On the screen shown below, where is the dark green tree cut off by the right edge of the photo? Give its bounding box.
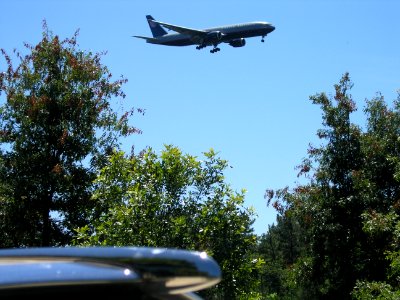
[352,94,400,300]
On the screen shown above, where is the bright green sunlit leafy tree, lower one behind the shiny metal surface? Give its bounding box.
[75,146,262,299]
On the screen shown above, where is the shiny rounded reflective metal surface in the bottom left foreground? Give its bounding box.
[0,247,221,299]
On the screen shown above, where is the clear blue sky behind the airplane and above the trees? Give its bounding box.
[0,0,400,234]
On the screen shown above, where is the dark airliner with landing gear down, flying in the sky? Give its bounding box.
[133,15,275,53]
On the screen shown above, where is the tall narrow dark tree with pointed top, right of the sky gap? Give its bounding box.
[303,74,368,299]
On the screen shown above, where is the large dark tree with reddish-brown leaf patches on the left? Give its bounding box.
[0,22,140,247]
